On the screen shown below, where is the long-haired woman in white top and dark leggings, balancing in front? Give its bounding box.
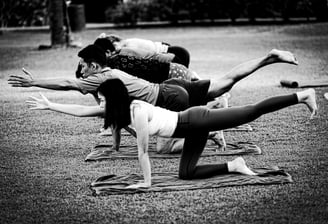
[27,79,317,188]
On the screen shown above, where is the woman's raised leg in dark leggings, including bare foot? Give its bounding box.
[174,89,317,137]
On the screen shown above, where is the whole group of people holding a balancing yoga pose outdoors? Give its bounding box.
[8,34,317,188]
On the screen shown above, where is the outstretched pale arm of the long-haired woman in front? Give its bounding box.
[26,93,104,117]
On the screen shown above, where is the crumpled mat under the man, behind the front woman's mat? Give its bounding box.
[85,142,262,162]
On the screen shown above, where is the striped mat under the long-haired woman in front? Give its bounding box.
[90,167,293,196]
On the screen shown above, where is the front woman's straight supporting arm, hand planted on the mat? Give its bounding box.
[128,106,151,188]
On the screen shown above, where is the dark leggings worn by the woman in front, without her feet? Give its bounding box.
[172,94,298,179]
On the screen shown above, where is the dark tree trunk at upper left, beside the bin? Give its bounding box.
[49,0,66,47]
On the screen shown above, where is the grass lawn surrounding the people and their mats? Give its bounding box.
[0,23,328,223]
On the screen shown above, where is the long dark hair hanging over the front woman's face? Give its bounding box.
[98,79,132,129]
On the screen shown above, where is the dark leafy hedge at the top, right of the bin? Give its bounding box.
[106,0,328,24]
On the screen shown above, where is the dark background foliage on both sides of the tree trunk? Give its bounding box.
[0,0,328,27]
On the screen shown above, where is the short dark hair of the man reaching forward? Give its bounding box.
[78,44,106,66]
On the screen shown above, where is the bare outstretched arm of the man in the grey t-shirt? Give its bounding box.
[8,68,81,91]
